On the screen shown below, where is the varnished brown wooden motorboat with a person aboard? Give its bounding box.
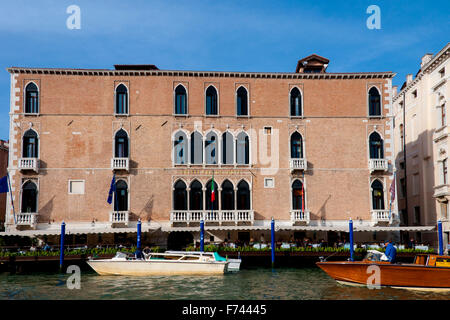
[316,250,450,291]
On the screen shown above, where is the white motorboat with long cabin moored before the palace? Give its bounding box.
[87,252,228,276]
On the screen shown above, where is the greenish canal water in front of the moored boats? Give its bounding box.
[0,267,450,300]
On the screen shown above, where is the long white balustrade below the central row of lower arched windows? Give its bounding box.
[170,210,254,225]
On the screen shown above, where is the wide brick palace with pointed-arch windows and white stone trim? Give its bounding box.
[0,54,408,248]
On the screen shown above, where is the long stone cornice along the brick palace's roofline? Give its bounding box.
[6,67,395,79]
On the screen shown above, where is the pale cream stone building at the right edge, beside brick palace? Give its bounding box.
[393,43,450,248]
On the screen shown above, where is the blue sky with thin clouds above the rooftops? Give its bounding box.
[0,0,450,140]
